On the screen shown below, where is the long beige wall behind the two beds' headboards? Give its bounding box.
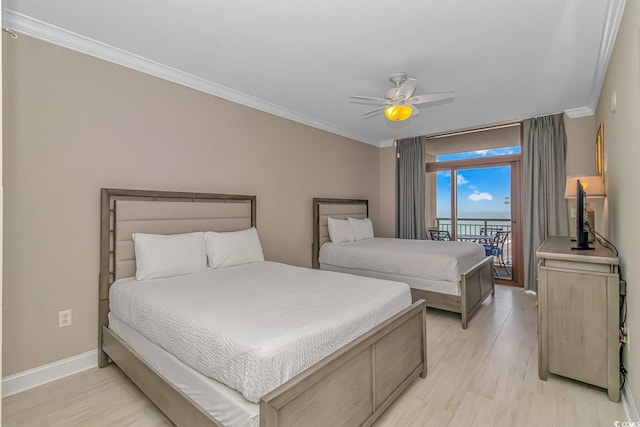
[3,35,386,376]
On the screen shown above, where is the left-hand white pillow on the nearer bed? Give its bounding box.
[132,232,207,280]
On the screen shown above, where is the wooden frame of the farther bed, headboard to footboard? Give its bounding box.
[312,198,495,329]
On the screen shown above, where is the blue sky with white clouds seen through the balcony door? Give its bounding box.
[436,147,520,218]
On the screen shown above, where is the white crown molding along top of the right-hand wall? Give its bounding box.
[578,0,626,112]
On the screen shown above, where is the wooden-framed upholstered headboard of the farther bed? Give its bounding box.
[311,198,369,268]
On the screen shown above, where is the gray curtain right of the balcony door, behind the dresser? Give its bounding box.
[522,114,569,291]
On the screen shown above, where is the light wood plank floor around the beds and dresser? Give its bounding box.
[2,286,625,427]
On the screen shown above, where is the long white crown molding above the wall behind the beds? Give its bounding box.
[2,9,370,146]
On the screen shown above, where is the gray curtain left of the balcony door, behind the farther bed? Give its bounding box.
[396,137,427,239]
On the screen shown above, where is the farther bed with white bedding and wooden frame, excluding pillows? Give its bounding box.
[312,198,495,329]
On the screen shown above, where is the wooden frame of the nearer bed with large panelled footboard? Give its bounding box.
[98,189,427,427]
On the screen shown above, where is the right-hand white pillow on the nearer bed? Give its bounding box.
[204,227,264,268]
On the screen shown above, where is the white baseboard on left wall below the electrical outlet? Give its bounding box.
[2,350,98,397]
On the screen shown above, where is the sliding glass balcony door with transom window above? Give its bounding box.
[425,124,523,286]
